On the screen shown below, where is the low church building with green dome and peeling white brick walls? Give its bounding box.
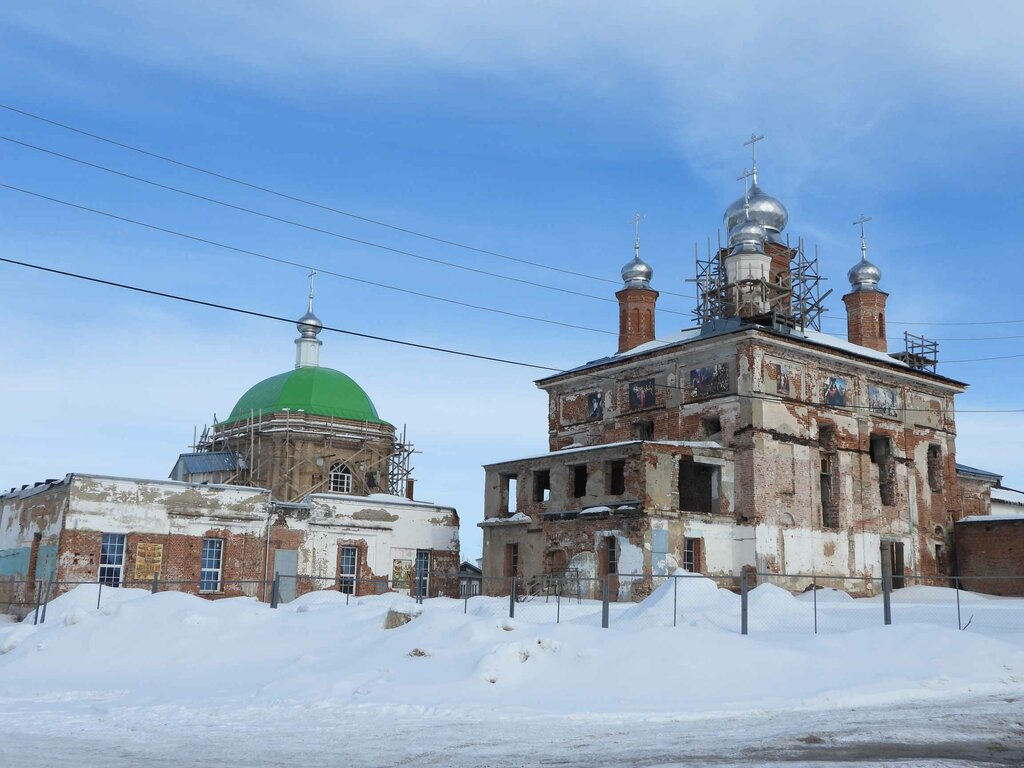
[0,291,460,611]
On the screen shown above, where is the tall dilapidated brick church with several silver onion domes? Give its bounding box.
[480,147,997,599]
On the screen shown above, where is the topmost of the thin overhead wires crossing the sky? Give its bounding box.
[0,103,694,299]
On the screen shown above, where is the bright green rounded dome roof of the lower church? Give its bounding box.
[225,367,387,424]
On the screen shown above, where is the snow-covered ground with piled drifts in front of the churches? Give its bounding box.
[0,579,1024,768]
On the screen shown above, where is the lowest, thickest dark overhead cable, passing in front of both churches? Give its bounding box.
[0,257,1024,414]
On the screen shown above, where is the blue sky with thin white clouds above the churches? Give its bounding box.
[0,1,1024,556]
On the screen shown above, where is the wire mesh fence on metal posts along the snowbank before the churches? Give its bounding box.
[0,571,1024,635]
